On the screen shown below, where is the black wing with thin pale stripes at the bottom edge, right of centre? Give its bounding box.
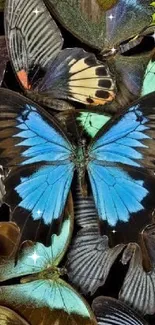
[92,296,148,325]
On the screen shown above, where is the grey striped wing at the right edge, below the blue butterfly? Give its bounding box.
[119,240,155,315]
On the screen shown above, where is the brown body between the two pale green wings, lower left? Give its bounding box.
[21,266,65,283]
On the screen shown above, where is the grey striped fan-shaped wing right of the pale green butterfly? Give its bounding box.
[67,225,125,295]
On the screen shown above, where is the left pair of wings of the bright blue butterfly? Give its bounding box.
[0,90,74,243]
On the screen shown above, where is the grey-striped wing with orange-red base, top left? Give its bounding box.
[5,0,63,89]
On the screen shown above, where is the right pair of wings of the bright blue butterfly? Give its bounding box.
[87,93,155,227]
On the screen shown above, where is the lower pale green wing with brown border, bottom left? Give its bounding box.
[0,274,97,325]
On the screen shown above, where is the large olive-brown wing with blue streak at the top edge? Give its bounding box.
[45,0,153,50]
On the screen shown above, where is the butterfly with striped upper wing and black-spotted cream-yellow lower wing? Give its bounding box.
[5,0,115,110]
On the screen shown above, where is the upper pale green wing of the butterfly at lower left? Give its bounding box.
[0,211,72,281]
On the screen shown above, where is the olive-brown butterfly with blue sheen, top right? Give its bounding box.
[44,0,154,109]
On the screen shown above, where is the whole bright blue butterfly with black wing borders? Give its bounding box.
[0,89,155,242]
